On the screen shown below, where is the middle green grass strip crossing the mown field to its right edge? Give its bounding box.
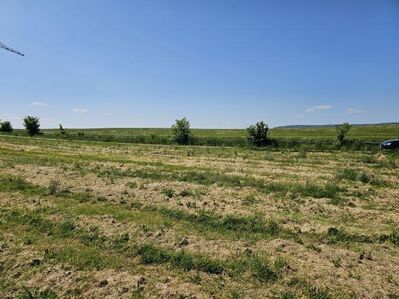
[0,176,399,251]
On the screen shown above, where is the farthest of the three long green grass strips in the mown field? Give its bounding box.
[1,139,395,207]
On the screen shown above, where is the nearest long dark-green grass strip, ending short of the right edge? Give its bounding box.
[4,210,284,282]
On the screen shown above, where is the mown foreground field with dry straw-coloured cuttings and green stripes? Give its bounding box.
[0,135,399,298]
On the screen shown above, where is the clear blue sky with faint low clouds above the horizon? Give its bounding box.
[0,0,399,128]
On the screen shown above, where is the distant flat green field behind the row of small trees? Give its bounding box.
[6,124,399,147]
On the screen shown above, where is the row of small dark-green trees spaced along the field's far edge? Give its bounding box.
[0,116,351,147]
